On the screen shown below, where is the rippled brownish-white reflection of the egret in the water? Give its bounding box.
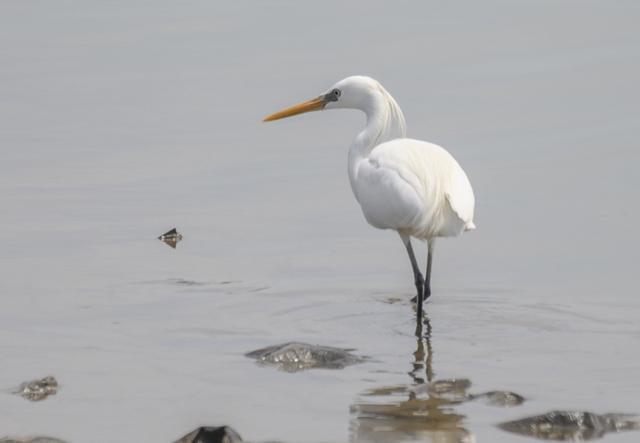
[350,316,475,443]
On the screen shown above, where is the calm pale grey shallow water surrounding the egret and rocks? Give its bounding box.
[0,0,640,443]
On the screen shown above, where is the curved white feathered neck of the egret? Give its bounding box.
[349,86,407,187]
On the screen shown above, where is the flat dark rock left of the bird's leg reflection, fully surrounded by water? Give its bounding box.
[246,342,365,372]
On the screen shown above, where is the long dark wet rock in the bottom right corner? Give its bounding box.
[498,411,640,441]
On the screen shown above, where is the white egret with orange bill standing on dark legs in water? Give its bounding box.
[264,76,475,328]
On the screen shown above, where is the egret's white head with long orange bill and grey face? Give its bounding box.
[264,75,383,122]
